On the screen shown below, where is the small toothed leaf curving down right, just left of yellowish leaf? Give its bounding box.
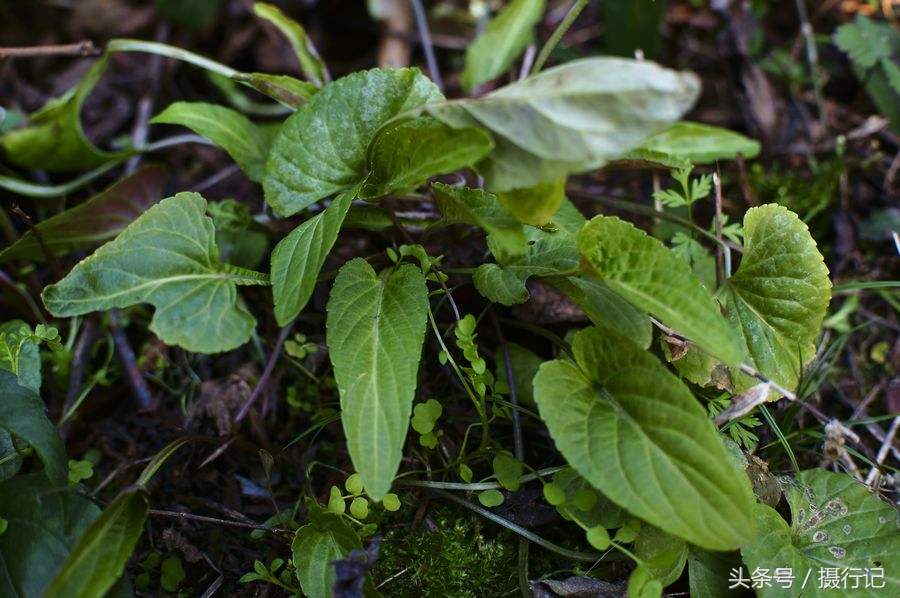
[431,183,526,259]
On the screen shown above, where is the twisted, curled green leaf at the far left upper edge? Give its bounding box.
[0,54,133,172]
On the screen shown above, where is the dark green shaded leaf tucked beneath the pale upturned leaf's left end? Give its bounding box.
[359,117,494,199]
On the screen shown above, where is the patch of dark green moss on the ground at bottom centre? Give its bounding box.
[374,507,518,598]
